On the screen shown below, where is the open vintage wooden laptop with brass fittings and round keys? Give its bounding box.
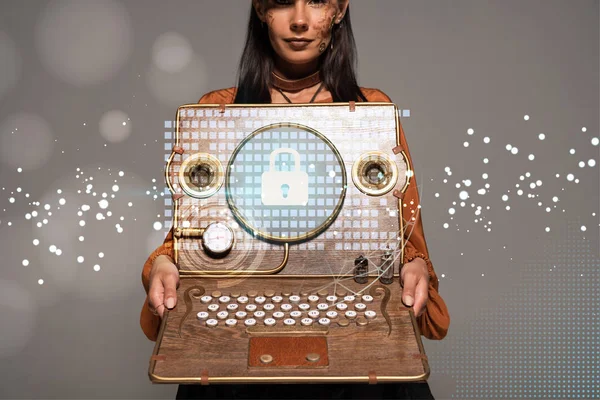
[149,103,429,384]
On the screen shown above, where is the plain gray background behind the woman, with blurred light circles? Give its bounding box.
[0,0,600,398]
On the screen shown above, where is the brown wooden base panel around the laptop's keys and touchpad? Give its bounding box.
[149,277,429,383]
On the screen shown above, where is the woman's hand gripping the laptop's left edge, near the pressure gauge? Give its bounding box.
[148,255,179,318]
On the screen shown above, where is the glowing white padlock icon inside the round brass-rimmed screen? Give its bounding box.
[260,148,308,206]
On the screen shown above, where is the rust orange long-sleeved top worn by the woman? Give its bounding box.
[140,88,450,341]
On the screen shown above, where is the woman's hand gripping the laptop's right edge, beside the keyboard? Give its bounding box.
[400,258,429,317]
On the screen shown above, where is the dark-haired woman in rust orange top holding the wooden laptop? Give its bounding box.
[141,0,450,398]
